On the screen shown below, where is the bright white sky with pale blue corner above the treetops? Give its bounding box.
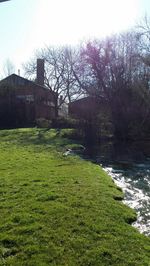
[0,0,150,76]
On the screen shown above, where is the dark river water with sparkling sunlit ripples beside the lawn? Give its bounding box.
[84,142,150,236]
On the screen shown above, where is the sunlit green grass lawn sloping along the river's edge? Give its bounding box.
[0,129,150,266]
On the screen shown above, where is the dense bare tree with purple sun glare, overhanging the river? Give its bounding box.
[76,32,150,138]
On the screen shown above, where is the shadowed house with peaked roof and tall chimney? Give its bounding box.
[0,59,55,127]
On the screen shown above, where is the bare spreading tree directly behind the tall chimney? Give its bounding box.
[24,46,84,116]
